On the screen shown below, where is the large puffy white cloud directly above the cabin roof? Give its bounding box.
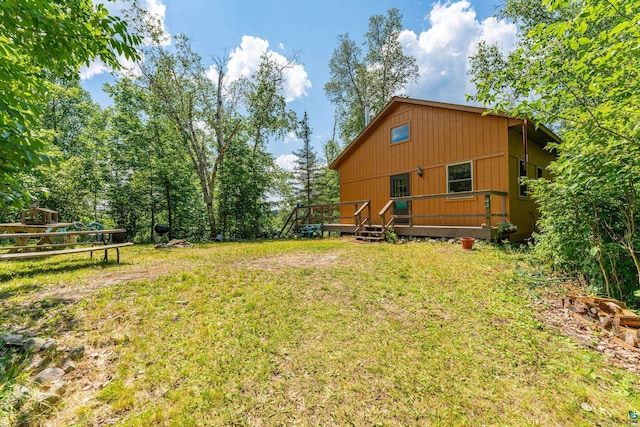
[400,0,517,103]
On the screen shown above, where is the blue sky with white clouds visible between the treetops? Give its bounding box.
[81,0,516,171]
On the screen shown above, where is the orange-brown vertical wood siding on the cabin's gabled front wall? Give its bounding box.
[338,103,510,226]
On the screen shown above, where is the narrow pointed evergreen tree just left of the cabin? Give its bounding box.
[293,111,320,205]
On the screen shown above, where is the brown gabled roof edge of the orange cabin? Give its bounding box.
[329,96,560,169]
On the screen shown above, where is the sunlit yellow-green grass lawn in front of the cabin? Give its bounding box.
[0,239,640,426]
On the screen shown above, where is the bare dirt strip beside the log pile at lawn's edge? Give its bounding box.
[540,298,640,373]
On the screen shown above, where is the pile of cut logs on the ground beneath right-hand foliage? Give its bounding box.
[561,297,640,352]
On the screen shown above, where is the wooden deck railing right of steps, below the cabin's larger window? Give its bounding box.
[378,190,507,234]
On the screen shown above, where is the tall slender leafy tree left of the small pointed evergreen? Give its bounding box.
[218,53,296,238]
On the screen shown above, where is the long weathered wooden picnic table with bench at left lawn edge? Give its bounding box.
[0,229,133,262]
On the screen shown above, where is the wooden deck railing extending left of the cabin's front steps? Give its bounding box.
[280,200,371,236]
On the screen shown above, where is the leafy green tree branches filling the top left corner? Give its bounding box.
[0,0,140,206]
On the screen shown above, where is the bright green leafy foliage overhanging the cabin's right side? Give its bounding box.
[473,0,640,298]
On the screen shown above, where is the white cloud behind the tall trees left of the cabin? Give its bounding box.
[207,36,312,102]
